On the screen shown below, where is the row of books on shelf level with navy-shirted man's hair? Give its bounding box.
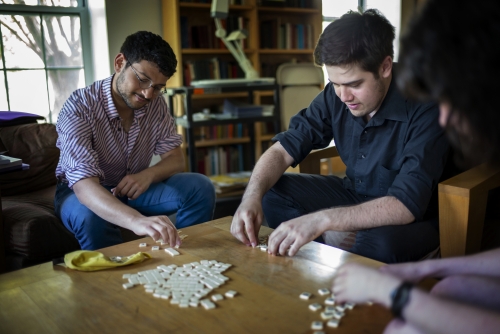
[260,18,315,50]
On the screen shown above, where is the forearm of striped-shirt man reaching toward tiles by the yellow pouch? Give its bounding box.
[73,177,142,229]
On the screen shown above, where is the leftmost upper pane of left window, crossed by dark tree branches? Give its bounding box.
[0,15,43,68]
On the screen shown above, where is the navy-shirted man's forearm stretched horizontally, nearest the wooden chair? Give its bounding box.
[316,196,415,231]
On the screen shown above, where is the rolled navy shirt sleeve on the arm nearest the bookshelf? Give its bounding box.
[272,85,333,167]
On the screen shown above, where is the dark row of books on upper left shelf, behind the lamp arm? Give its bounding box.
[180,15,248,49]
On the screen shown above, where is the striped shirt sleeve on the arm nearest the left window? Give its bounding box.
[56,91,104,188]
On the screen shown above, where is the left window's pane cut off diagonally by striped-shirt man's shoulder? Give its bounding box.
[47,70,85,123]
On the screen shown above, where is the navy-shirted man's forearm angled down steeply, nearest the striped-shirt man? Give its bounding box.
[243,142,293,199]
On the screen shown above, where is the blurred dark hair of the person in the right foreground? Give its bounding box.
[397,0,500,162]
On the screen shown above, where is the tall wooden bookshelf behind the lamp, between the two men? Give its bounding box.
[162,0,322,176]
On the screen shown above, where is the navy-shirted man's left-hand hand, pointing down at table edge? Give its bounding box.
[231,199,264,247]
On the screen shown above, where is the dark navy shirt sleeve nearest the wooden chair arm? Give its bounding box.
[387,104,449,221]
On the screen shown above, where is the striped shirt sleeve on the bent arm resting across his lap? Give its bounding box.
[154,98,182,155]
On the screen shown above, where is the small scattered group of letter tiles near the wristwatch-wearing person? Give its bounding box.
[299,288,355,334]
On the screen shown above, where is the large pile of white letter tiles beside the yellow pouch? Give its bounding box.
[123,260,237,310]
